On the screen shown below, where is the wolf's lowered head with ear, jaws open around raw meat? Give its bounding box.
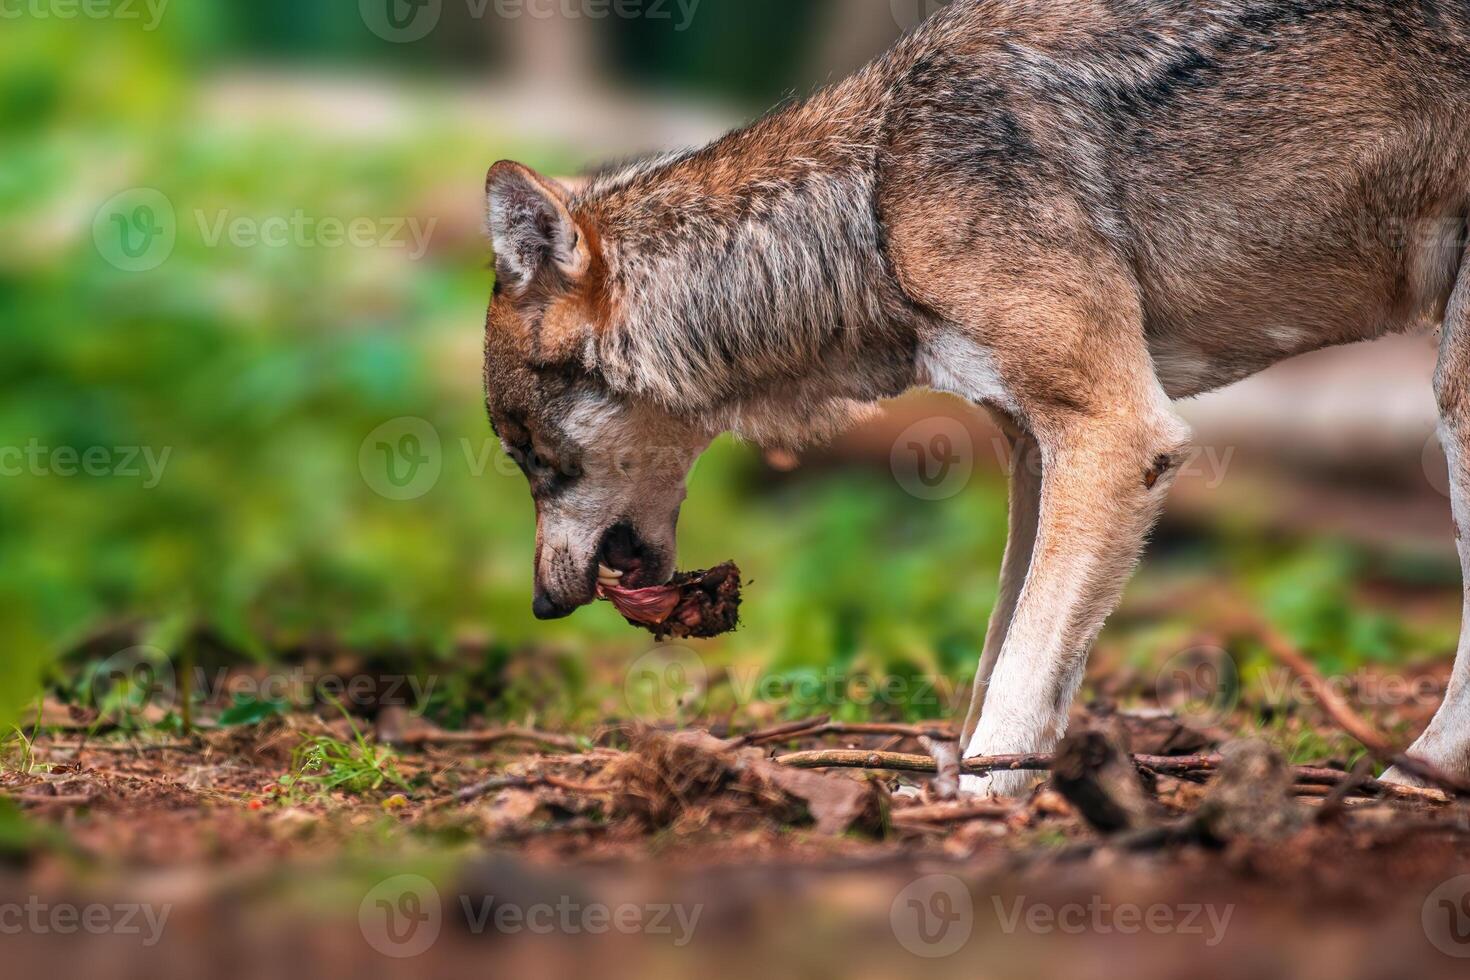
[485,163,713,619]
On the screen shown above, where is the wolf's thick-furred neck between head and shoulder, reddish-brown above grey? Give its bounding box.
[582,88,901,437]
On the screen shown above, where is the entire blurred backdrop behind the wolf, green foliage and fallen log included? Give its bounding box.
[0,0,1460,975]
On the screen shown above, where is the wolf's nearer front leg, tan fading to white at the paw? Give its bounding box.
[963,405,1189,796]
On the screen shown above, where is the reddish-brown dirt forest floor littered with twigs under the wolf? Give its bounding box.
[0,677,1470,979]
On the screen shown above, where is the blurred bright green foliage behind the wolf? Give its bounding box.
[0,3,1452,746]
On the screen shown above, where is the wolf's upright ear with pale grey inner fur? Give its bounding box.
[485,160,591,289]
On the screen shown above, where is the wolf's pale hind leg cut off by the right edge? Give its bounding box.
[1385,260,1470,783]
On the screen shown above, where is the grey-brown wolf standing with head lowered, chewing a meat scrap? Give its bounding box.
[485,0,1470,795]
